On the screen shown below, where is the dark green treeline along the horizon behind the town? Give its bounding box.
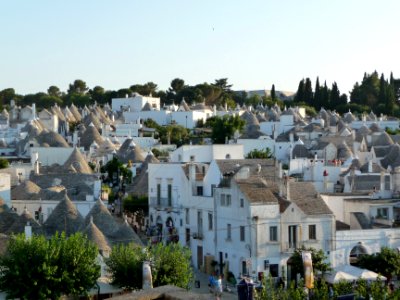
[0,71,400,117]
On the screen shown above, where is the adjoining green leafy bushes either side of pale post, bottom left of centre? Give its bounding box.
[106,243,193,290]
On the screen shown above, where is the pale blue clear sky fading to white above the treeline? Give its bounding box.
[0,0,400,94]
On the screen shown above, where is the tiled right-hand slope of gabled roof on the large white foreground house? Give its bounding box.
[288,181,333,215]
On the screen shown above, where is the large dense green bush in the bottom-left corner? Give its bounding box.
[0,233,100,299]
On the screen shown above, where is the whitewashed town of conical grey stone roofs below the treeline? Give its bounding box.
[0,93,400,299]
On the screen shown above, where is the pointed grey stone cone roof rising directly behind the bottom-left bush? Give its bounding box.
[44,195,84,236]
